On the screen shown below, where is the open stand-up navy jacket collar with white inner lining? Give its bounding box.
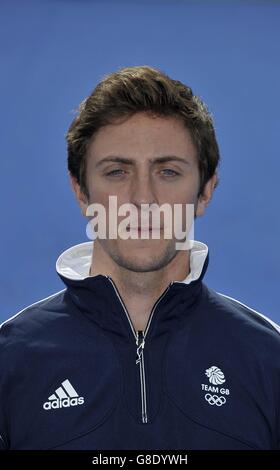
[56,241,209,340]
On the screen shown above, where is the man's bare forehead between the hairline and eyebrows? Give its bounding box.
[88,113,196,163]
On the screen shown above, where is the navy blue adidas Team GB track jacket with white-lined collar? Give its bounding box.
[0,242,280,450]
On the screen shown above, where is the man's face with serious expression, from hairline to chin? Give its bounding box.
[71,113,213,272]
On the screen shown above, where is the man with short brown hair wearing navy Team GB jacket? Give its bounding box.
[0,66,280,450]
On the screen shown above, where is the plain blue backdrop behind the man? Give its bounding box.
[0,0,280,321]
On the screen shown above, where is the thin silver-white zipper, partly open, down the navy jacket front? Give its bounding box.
[106,276,174,424]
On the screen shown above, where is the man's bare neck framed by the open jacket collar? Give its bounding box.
[90,241,190,331]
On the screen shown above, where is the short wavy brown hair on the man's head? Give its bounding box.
[66,65,220,197]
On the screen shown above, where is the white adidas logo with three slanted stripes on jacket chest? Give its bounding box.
[43,379,85,410]
